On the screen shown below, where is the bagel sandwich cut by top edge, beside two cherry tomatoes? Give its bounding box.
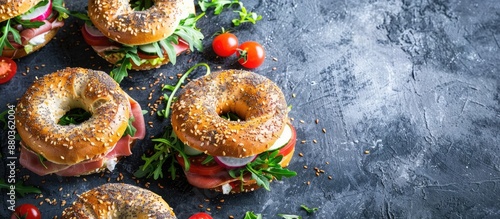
[81,0,203,82]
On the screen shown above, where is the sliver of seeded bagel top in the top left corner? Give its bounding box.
[0,0,42,22]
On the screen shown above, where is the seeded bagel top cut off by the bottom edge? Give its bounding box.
[62,183,177,219]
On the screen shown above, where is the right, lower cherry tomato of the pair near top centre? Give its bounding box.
[236,41,266,68]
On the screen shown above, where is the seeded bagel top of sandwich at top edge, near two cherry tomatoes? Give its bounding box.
[88,0,195,45]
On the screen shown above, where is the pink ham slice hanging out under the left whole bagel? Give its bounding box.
[20,97,146,176]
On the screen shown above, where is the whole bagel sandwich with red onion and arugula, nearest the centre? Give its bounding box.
[171,70,296,194]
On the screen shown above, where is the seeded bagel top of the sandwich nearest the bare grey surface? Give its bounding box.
[171,70,288,157]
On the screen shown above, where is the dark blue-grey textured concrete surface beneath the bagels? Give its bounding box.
[0,0,500,218]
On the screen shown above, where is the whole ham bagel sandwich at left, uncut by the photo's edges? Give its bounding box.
[15,68,145,176]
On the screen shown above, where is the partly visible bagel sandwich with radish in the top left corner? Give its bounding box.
[0,0,68,59]
